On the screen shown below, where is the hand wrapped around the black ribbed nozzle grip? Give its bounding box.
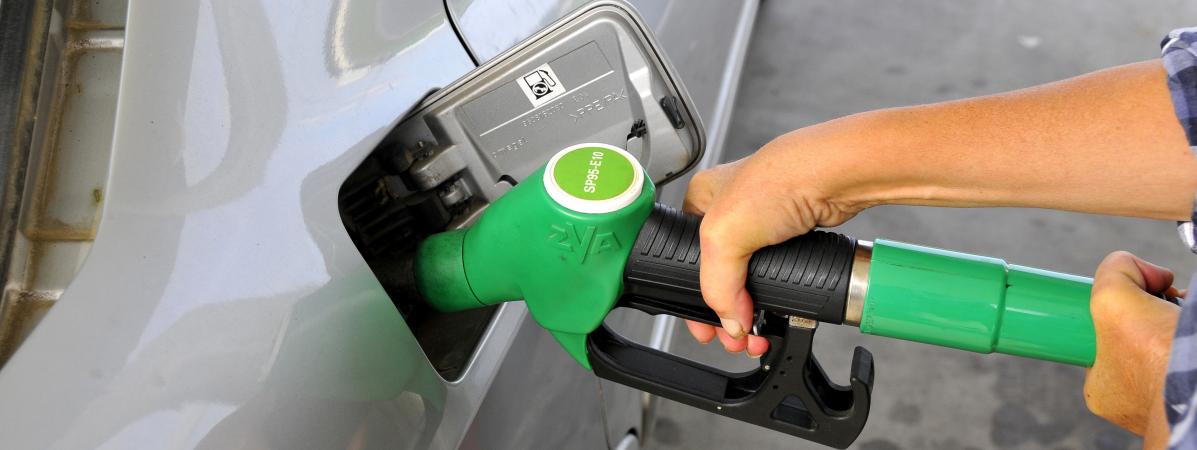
[685,130,863,358]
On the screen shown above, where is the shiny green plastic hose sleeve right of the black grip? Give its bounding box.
[861,239,1096,367]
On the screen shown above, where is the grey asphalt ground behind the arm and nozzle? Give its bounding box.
[646,0,1197,450]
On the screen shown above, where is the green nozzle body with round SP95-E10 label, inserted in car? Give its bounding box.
[414,144,655,369]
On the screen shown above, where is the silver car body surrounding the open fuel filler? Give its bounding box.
[0,0,755,449]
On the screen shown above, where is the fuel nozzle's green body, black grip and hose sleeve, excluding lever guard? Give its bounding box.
[417,145,1095,367]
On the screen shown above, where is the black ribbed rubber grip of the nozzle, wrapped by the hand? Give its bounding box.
[624,205,856,324]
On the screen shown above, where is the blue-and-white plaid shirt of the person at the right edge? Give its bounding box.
[1162,28,1197,450]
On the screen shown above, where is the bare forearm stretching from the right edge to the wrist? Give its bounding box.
[782,61,1197,219]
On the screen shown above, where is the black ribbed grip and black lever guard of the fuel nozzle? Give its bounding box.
[596,205,874,448]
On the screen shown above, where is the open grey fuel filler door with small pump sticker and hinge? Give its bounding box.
[388,2,704,201]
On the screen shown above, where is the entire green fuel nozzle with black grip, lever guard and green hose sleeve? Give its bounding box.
[414,144,1095,448]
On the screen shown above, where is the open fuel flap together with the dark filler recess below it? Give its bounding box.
[340,2,704,379]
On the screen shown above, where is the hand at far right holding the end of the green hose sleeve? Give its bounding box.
[1084,251,1181,448]
